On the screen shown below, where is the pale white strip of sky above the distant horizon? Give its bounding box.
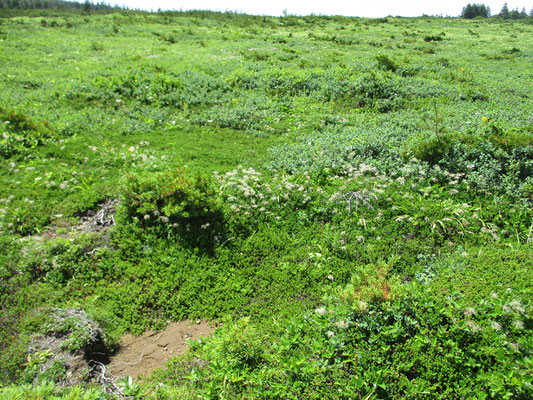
[102,0,533,18]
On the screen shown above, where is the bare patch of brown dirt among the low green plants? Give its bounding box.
[107,321,215,378]
